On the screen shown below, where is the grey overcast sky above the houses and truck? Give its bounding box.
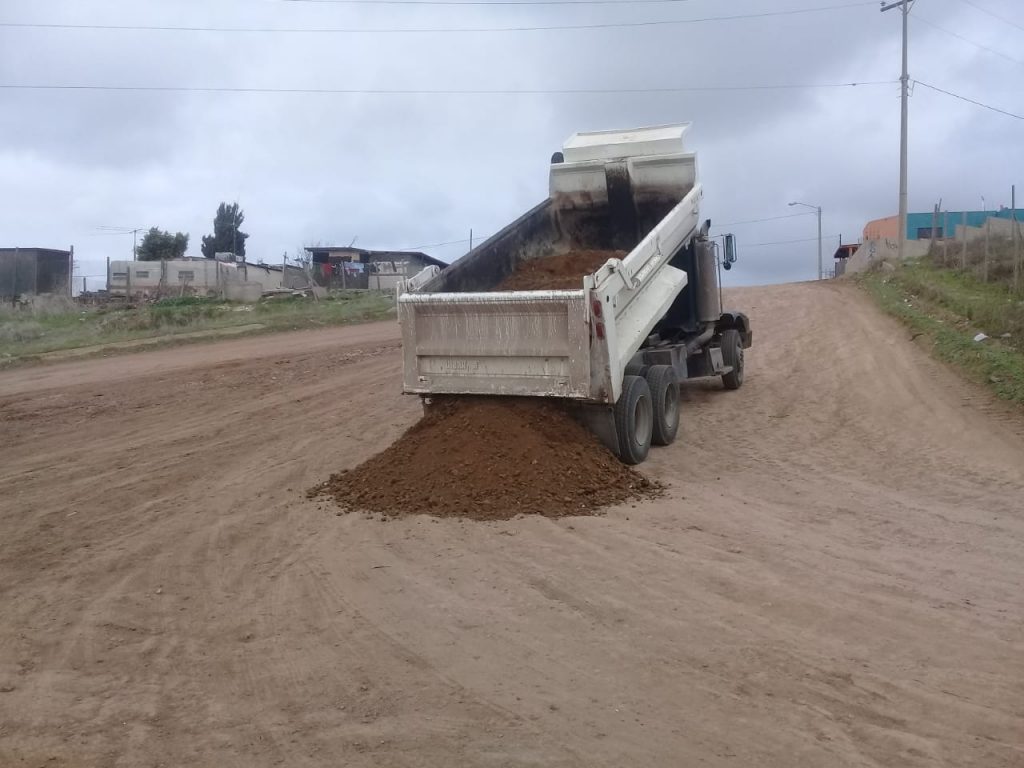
[0,0,1024,288]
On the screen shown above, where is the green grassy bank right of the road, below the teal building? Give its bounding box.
[857,262,1024,406]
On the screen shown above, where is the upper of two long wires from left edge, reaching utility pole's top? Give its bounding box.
[0,0,874,35]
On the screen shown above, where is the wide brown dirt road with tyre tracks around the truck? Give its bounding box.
[0,284,1024,768]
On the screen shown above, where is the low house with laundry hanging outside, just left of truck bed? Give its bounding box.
[306,246,447,291]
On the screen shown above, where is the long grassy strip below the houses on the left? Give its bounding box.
[0,291,394,367]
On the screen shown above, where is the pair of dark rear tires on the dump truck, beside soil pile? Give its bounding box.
[614,366,679,465]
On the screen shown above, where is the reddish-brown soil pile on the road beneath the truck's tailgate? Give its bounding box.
[310,397,659,520]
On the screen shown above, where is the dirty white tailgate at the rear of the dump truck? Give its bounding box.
[398,291,591,399]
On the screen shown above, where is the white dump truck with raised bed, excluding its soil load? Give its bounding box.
[398,124,752,464]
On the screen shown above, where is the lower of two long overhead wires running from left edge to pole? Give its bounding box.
[0,80,895,96]
